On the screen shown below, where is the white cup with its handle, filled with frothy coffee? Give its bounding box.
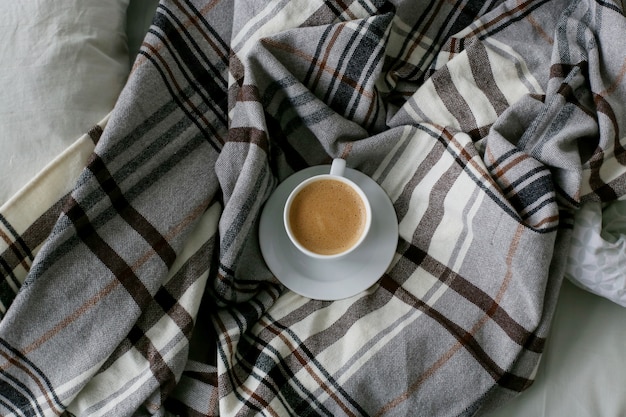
[283,158,372,259]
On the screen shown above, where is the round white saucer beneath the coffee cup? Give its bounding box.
[259,165,398,300]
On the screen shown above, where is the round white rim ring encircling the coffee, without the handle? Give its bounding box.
[283,174,372,259]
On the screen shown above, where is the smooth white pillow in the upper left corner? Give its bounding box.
[0,0,130,206]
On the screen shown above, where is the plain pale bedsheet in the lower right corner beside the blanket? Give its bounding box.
[489,281,626,417]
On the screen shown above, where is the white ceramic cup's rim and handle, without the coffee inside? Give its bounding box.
[283,158,372,259]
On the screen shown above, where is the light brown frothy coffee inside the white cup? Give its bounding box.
[289,179,366,255]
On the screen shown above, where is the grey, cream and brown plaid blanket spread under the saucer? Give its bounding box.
[0,0,626,416]
